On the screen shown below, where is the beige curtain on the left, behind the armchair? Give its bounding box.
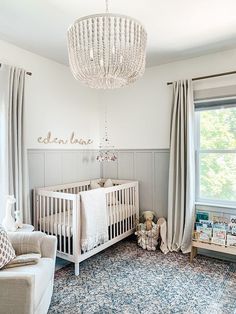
[0,64,30,222]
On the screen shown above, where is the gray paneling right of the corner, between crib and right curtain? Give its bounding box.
[102,149,169,217]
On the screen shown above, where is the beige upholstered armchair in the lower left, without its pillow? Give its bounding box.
[0,232,56,314]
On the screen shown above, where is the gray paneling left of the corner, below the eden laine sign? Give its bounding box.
[28,149,101,190]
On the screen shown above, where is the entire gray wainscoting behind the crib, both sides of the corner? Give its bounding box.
[28,149,169,217]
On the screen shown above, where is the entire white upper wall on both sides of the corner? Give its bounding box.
[0,41,236,149]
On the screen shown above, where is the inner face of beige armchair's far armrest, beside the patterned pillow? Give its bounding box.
[8,231,46,255]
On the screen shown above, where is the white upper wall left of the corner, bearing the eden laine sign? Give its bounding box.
[0,41,99,149]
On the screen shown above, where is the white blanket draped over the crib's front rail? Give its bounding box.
[80,188,108,252]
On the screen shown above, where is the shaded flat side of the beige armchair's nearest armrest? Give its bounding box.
[0,271,34,314]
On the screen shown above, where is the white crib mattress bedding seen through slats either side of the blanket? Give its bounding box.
[38,204,135,237]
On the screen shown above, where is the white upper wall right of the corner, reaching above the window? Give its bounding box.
[99,49,236,149]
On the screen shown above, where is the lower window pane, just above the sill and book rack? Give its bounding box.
[199,153,236,201]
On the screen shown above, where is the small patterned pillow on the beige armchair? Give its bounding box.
[0,226,16,269]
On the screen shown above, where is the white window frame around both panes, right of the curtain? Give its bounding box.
[194,100,236,209]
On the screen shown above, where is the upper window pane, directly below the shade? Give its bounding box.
[200,107,236,149]
